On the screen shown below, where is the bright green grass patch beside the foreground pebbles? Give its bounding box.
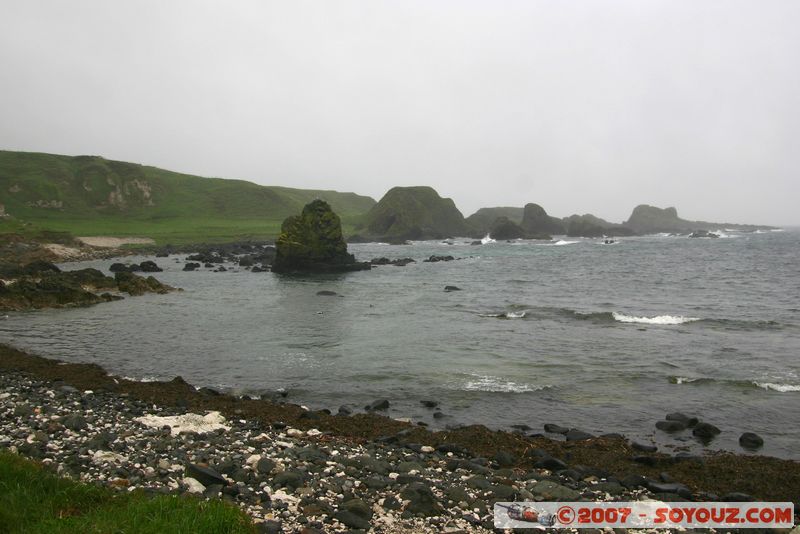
[0,451,255,534]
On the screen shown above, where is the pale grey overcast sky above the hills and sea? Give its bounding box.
[0,0,800,224]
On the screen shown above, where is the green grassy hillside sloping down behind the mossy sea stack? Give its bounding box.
[0,151,375,242]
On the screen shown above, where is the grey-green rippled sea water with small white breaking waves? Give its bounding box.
[0,230,800,459]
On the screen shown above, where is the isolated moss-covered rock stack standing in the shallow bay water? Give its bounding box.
[272,200,371,273]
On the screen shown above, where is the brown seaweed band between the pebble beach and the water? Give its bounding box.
[0,345,800,510]
